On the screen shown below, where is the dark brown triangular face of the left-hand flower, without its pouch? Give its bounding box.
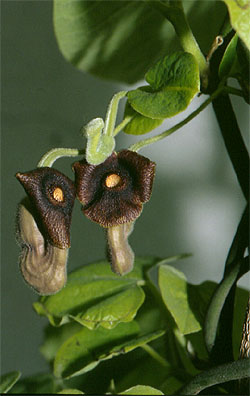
[16,167,75,249]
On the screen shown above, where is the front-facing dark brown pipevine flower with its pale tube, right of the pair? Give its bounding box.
[73,150,155,275]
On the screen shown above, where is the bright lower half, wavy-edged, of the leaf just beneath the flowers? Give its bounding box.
[72,286,145,329]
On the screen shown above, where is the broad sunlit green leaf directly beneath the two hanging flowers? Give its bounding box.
[33,257,157,328]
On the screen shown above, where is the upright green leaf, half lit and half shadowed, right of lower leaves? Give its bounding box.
[159,265,216,335]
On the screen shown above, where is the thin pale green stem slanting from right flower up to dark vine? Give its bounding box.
[129,88,224,152]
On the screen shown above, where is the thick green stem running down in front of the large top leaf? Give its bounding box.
[149,0,208,80]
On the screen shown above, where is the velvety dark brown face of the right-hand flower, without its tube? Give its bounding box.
[73,150,155,227]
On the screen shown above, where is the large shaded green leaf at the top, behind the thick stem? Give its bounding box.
[54,0,226,83]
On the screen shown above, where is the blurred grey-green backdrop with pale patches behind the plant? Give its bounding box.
[1,0,249,375]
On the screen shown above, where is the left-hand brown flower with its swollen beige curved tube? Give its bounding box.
[16,167,75,295]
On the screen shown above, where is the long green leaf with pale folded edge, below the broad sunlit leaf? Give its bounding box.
[54,321,164,378]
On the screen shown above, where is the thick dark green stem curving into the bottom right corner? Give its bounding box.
[178,359,250,395]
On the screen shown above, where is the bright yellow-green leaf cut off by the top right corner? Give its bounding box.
[223,0,250,49]
